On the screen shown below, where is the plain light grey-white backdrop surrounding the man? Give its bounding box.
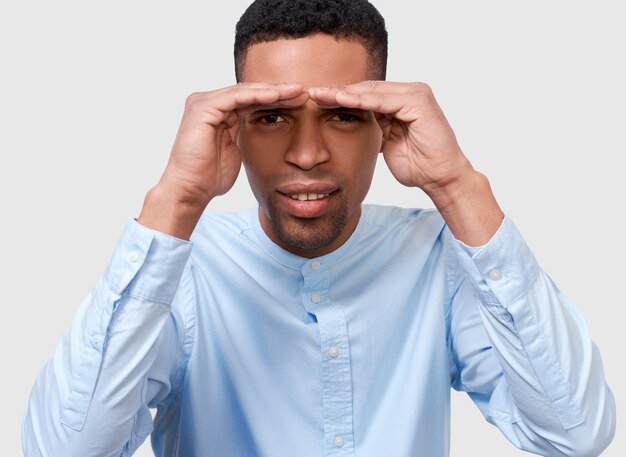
[0,0,626,457]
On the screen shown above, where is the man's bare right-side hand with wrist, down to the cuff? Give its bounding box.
[308,81,504,245]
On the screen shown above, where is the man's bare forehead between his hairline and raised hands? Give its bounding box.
[243,34,372,88]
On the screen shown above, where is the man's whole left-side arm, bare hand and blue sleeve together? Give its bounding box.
[22,83,308,457]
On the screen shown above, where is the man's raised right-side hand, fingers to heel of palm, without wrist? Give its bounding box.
[309,81,474,193]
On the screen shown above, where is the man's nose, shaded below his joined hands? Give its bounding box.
[284,119,330,170]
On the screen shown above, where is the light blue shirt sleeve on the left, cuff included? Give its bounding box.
[22,219,195,457]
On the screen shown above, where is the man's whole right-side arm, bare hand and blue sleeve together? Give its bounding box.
[309,81,615,456]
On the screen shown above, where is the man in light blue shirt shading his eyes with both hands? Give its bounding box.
[23,0,615,457]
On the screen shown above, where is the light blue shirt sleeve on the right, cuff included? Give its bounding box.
[444,215,615,456]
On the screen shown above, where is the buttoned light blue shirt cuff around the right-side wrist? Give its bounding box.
[453,215,539,308]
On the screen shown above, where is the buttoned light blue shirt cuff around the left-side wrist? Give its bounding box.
[104,218,193,304]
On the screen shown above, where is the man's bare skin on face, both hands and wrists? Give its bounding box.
[138,34,504,253]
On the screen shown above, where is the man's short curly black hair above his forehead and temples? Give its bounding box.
[235,0,387,82]
